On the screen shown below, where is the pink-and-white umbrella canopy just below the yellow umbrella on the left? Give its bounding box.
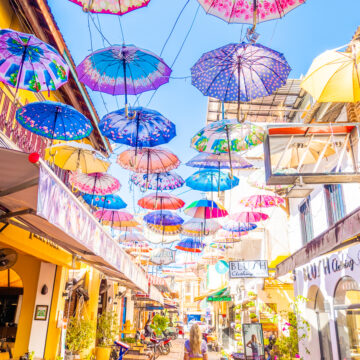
[69,171,121,195]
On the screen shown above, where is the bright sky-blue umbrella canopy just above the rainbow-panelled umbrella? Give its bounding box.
[186,169,239,191]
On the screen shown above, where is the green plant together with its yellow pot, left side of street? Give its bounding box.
[95,311,118,360]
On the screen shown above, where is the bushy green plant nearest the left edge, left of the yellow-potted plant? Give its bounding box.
[65,317,94,354]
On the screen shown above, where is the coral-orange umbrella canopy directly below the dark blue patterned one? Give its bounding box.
[117,147,180,174]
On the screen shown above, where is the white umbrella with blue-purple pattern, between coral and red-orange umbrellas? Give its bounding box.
[130,171,185,191]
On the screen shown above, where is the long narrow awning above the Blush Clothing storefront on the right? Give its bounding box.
[276,204,360,277]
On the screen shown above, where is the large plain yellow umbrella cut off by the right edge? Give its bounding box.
[301,45,360,102]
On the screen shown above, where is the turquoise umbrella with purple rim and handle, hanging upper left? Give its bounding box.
[76,45,171,114]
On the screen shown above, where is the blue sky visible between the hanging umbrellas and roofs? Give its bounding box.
[48,0,360,211]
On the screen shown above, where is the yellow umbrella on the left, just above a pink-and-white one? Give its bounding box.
[45,141,110,174]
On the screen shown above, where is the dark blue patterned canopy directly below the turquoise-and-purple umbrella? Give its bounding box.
[99,107,176,149]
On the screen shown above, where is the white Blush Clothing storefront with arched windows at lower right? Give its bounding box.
[295,245,360,360]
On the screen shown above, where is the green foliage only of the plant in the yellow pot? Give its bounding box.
[96,311,118,347]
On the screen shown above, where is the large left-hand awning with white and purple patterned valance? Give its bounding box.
[0,148,148,292]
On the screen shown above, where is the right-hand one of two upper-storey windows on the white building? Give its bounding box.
[324,184,345,226]
